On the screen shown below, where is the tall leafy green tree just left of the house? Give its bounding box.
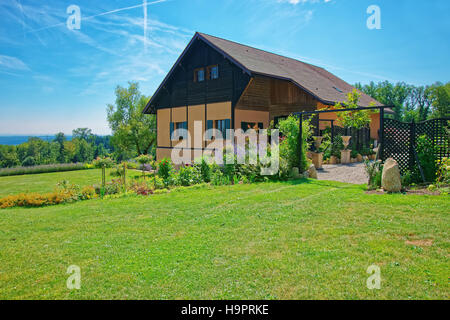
[107,82,156,155]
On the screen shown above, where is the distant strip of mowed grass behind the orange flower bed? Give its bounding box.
[0,169,141,197]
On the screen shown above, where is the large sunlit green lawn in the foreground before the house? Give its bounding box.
[0,180,450,299]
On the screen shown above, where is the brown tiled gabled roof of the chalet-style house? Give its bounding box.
[144,32,383,112]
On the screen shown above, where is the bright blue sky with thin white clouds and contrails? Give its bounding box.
[0,0,450,134]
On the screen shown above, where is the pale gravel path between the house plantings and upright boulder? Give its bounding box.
[317,163,368,184]
